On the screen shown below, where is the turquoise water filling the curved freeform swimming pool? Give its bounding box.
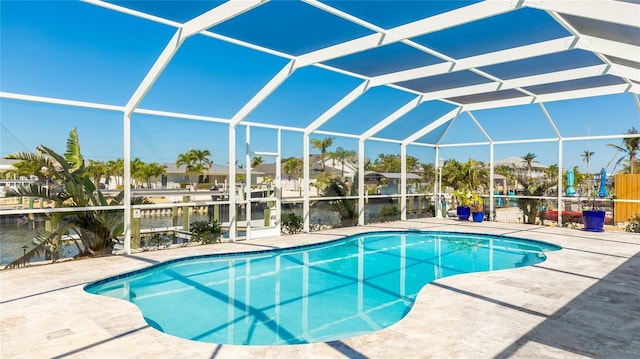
[85,231,560,345]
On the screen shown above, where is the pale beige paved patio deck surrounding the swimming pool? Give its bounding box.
[0,219,640,358]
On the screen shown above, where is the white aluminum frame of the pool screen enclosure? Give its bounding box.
[0,0,640,254]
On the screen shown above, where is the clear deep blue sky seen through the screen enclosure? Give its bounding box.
[0,0,640,172]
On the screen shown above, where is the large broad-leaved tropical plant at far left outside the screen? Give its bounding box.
[6,128,134,268]
